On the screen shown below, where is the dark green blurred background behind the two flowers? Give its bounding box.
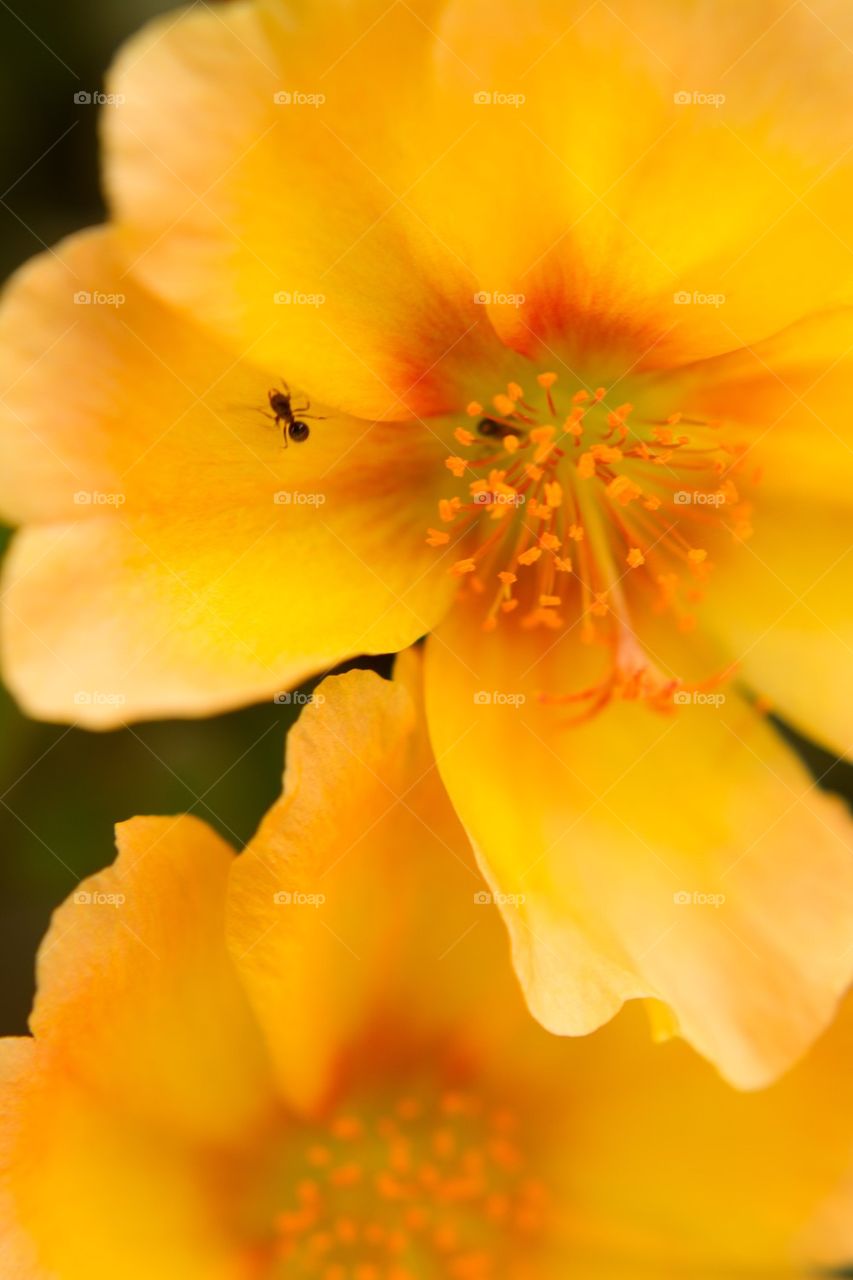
[0,0,853,1034]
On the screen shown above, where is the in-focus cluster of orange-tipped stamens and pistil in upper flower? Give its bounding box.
[427,372,752,716]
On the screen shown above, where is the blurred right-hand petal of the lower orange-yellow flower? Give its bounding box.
[540,998,853,1276]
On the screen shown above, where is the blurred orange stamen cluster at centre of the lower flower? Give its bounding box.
[262,1091,547,1280]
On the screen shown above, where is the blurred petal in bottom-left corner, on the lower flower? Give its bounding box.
[0,1039,246,1280]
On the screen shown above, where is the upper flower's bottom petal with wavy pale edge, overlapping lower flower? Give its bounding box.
[427,613,853,1088]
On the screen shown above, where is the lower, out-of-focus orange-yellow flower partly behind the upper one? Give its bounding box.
[0,671,853,1280]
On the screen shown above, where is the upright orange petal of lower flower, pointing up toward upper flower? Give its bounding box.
[229,657,489,1108]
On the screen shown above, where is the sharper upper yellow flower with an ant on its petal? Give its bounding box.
[0,0,853,1087]
